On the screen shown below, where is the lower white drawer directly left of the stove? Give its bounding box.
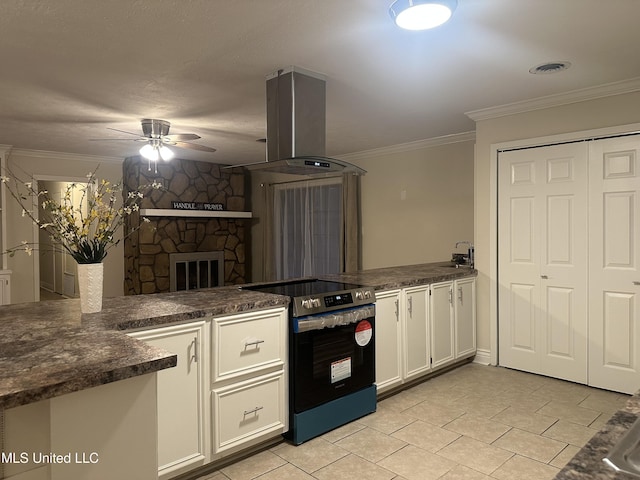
[211,371,287,453]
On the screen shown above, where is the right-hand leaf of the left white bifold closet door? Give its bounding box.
[539,156,587,383]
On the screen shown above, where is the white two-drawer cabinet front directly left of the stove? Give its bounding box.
[211,308,289,459]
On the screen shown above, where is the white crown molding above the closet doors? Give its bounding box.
[465,77,640,122]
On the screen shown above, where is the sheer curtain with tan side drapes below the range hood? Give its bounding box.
[262,174,362,281]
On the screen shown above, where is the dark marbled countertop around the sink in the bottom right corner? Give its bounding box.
[555,392,640,480]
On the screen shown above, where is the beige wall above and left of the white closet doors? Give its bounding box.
[475,92,640,351]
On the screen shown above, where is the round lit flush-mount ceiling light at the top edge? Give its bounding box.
[389,0,458,30]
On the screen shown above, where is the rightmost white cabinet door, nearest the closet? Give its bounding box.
[454,277,476,358]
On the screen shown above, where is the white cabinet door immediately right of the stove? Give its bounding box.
[375,290,402,393]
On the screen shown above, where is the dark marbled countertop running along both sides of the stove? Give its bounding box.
[0,262,476,409]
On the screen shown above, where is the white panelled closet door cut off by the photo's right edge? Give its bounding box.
[589,135,640,393]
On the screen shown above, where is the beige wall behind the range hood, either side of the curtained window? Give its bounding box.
[251,136,474,281]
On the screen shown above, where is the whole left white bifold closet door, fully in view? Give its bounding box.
[498,142,588,383]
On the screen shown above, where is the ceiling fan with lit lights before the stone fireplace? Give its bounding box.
[92,118,216,173]
